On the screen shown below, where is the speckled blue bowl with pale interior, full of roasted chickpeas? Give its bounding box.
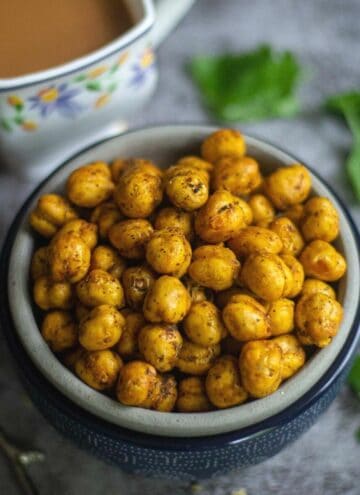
[1,125,360,480]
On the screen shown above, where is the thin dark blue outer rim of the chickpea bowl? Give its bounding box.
[0,123,360,451]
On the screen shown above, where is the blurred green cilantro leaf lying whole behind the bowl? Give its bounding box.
[190,45,301,121]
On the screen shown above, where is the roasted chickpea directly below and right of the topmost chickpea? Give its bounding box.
[212,156,263,196]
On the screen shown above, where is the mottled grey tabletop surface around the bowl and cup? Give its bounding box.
[0,0,360,495]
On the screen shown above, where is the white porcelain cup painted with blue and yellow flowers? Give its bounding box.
[0,0,194,179]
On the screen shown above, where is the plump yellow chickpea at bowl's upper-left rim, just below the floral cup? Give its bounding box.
[66,162,114,208]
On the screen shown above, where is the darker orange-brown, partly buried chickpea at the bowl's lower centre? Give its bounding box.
[176,340,221,375]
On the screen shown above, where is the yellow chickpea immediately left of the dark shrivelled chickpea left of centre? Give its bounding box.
[76,269,125,308]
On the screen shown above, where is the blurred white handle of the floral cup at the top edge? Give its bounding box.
[152,0,195,48]
